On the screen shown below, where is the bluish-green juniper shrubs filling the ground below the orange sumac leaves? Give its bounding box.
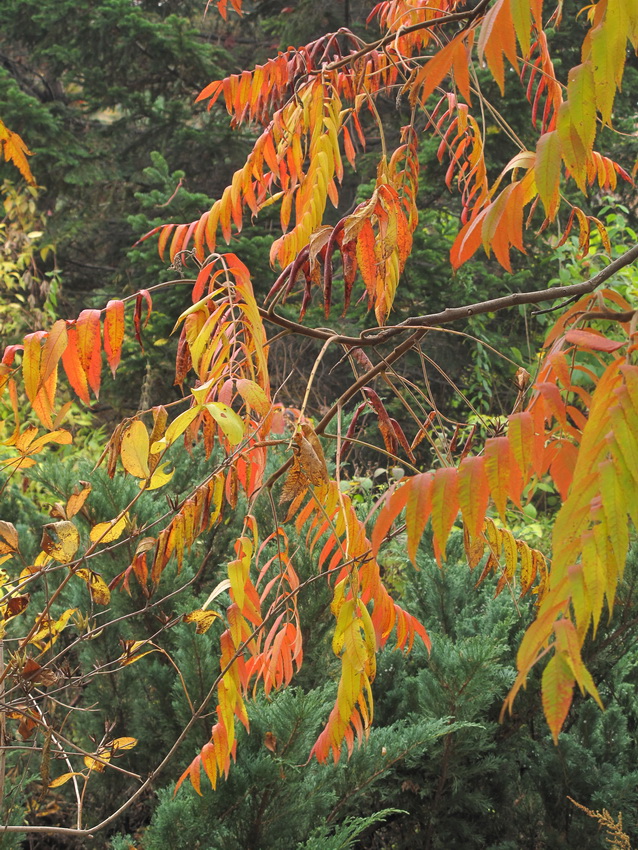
[6,444,638,850]
